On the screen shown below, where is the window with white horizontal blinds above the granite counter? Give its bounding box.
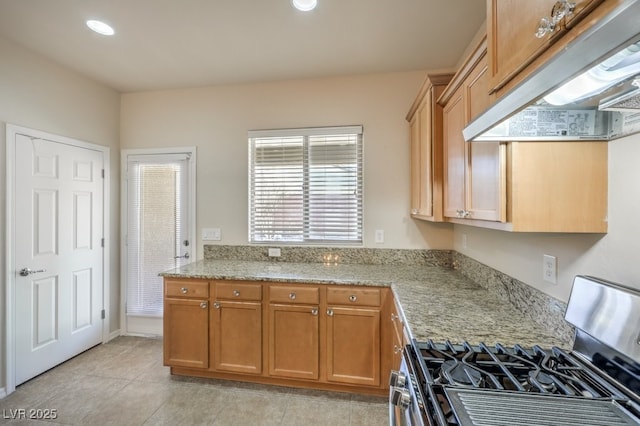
[249,126,363,244]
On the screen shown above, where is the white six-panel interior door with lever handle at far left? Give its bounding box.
[8,134,104,385]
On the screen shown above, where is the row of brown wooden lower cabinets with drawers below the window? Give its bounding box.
[164,278,394,395]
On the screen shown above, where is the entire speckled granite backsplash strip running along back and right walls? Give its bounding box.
[204,245,574,342]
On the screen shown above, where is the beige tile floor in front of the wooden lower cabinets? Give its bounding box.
[0,337,388,426]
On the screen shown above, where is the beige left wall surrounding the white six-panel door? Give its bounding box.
[0,38,120,388]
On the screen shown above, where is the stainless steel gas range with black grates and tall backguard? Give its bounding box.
[389,276,640,426]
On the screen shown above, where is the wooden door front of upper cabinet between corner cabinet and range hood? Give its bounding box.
[438,39,506,221]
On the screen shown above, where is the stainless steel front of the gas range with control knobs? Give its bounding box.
[389,345,429,426]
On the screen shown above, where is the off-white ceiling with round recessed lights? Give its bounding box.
[0,0,485,92]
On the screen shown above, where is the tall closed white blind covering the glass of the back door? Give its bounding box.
[126,154,188,316]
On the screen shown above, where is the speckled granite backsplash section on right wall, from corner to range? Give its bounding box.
[452,252,574,342]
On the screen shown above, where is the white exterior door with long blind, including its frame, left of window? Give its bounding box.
[123,152,195,335]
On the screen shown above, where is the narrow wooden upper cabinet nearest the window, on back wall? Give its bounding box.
[407,74,453,221]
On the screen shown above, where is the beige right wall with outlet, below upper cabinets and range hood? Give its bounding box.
[454,134,640,301]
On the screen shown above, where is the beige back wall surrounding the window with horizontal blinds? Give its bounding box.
[120,72,453,256]
